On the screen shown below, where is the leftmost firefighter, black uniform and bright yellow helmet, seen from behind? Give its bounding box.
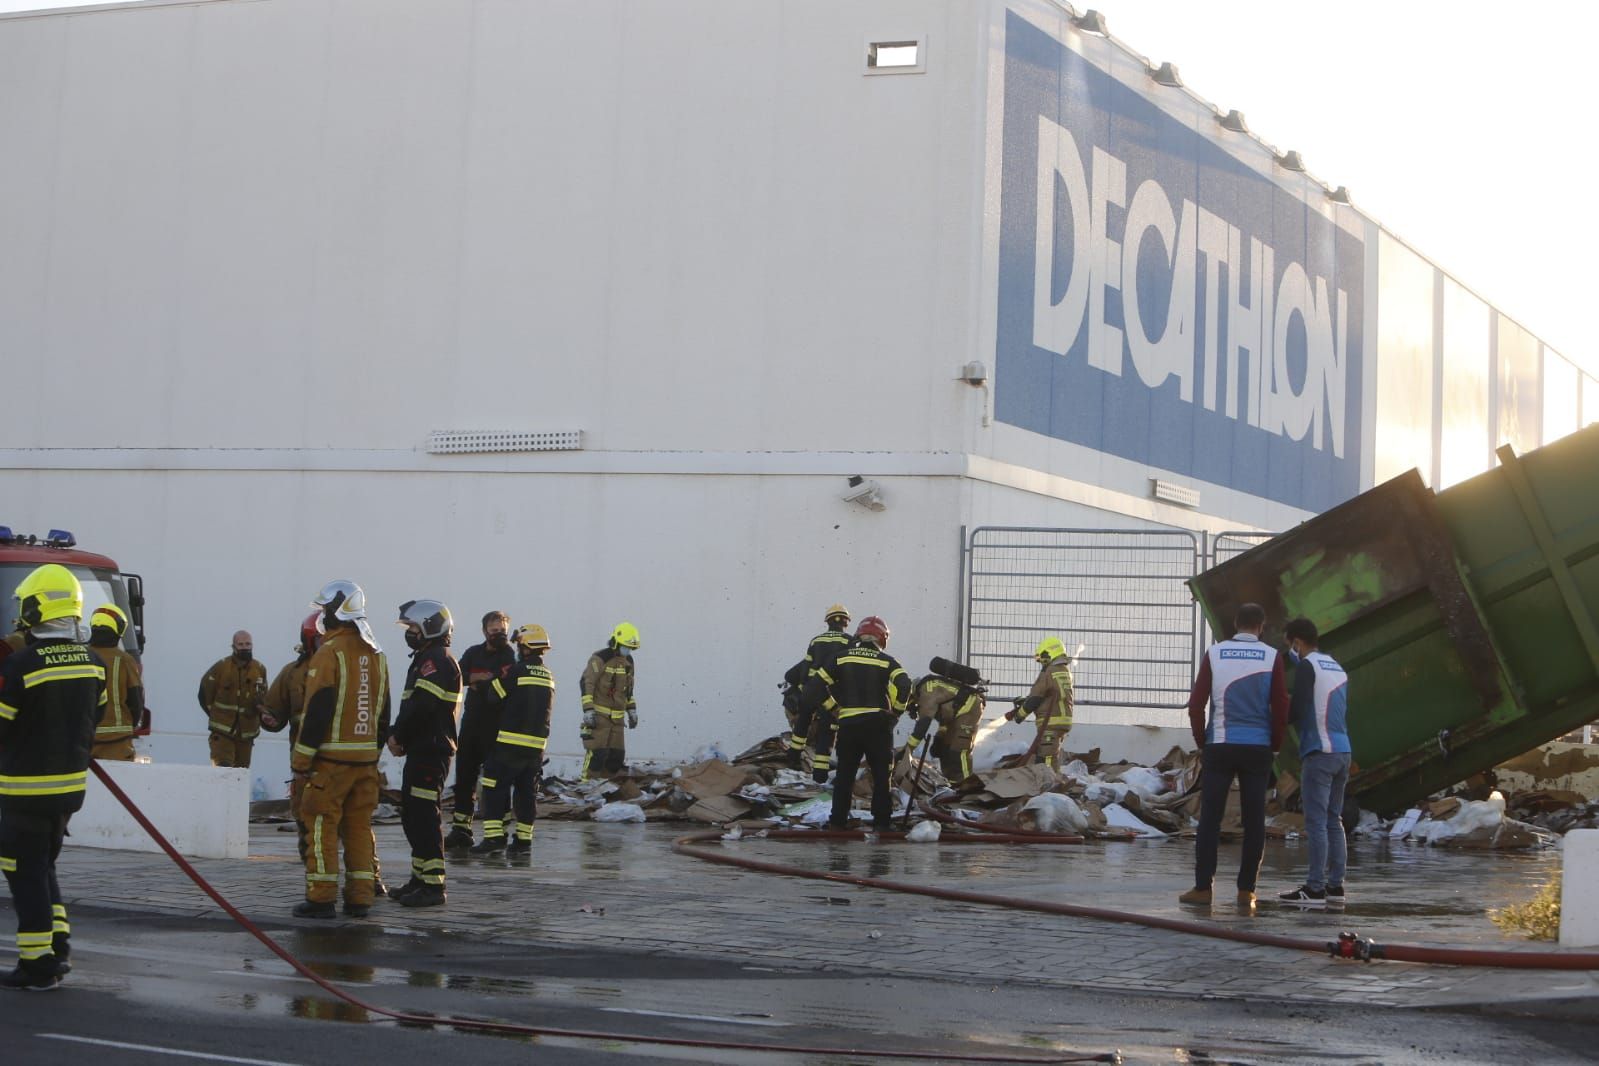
[0,563,107,989]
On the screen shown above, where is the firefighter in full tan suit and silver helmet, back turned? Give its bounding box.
[289,580,389,917]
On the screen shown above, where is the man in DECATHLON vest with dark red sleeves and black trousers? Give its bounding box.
[1177,604,1289,908]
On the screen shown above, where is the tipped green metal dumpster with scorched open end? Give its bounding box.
[1190,425,1599,813]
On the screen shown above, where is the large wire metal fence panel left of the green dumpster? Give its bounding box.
[966,527,1201,708]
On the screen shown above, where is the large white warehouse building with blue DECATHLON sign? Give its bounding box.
[0,0,1599,791]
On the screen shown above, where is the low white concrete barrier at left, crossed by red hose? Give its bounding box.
[67,762,249,858]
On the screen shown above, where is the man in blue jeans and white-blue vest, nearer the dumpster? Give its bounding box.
[1278,619,1351,908]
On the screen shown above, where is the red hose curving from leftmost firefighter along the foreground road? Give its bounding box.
[90,761,1121,1066]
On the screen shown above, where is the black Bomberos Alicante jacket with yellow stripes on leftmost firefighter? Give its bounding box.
[0,641,106,817]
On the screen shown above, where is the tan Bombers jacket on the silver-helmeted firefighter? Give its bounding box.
[289,625,389,770]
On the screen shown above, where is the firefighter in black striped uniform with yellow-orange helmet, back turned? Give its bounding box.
[472,625,555,855]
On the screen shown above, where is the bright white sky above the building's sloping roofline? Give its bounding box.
[0,0,1599,374]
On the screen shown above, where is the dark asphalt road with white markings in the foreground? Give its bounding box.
[0,898,1599,1066]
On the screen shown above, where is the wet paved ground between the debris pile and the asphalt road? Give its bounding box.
[31,821,1599,1007]
